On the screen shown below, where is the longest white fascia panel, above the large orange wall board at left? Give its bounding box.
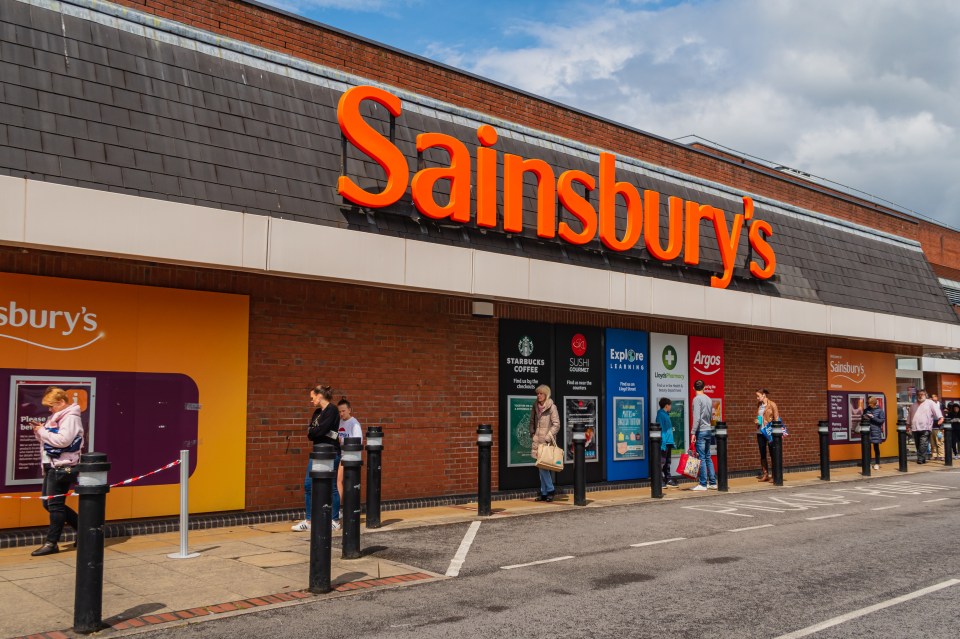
[24,180,243,267]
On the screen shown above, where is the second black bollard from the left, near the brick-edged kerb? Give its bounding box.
[309,444,337,595]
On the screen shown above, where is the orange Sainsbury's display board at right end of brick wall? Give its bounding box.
[824,348,897,461]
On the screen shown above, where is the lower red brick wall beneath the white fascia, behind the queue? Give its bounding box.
[0,247,921,510]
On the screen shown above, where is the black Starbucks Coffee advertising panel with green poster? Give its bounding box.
[498,320,563,490]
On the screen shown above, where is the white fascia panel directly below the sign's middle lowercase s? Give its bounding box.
[530,260,610,310]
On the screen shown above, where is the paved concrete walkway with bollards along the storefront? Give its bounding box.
[0,463,956,637]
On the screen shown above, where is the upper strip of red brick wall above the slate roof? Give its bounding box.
[113,0,960,268]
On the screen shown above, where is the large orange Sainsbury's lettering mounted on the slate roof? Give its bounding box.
[337,86,777,288]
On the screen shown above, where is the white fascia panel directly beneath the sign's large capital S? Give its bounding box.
[267,219,406,286]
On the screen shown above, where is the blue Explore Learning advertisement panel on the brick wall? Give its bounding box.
[605,328,650,481]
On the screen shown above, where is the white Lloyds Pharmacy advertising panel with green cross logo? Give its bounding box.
[647,333,690,462]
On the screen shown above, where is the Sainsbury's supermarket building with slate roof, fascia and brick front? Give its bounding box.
[0,0,960,528]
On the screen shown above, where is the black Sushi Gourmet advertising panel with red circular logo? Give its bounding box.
[554,326,606,483]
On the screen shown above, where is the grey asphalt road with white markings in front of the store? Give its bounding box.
[135,471,960,639]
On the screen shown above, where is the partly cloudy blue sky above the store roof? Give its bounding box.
[260,0,960,228]
